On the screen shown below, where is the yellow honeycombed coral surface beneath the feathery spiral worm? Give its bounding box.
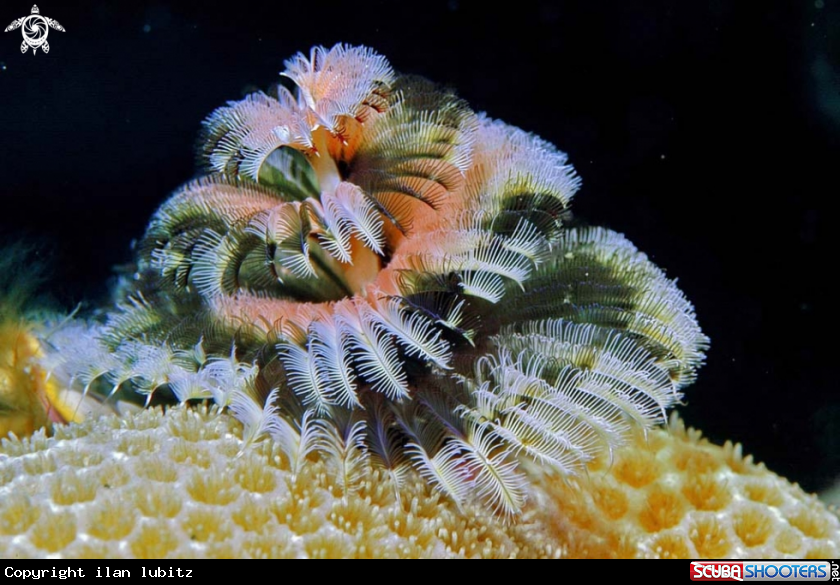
[0,407,840,558]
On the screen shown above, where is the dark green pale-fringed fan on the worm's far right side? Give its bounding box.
[482,228,709,387]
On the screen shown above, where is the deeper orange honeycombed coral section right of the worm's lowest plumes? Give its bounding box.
[540,418,840,559]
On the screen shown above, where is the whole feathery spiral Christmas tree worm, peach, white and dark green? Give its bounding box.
[46,45,708,516]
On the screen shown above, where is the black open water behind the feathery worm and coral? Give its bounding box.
[0,0,840,490]
